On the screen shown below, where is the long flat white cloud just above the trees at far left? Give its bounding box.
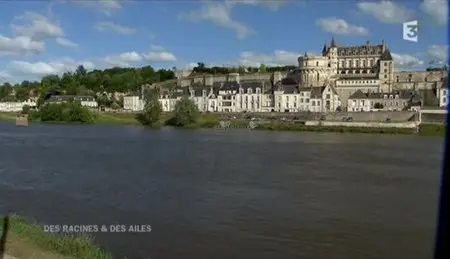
[9,59,95,77]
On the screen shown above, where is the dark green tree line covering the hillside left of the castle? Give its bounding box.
[0,66,175,106]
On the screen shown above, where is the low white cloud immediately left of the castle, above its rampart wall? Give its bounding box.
[239,50,301,67]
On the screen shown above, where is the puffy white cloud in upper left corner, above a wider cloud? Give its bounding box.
[11,12,64,40]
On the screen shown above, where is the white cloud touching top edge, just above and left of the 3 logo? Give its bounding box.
[357,0,414,23]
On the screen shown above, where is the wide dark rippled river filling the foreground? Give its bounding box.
[0,122,442,259]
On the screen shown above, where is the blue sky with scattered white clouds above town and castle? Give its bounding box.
[0,0,448,83]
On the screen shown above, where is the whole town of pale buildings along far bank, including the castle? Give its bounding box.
[0,38,448,113]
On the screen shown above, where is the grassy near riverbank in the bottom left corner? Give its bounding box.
[0,215,112,259]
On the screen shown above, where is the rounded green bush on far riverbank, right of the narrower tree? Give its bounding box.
[170,97,199,127]
